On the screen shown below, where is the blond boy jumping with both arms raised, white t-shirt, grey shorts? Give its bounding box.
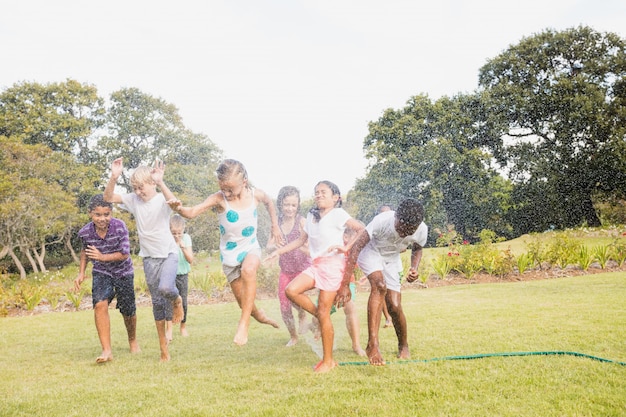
[104,158,184,362]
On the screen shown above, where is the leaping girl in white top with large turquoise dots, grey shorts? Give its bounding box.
[168,159,283,346]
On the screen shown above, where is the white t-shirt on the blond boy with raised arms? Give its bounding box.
[122,193,178,258]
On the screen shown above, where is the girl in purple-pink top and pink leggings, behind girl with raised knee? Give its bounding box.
[267,185,311,346]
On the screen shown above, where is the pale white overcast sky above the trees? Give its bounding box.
[0,0,626,199]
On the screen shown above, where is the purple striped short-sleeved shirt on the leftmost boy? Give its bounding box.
[78,218,134,277]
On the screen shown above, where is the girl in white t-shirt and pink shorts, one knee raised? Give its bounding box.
[267,181,363,373]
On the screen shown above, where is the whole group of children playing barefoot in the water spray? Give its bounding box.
[75,158,427,372]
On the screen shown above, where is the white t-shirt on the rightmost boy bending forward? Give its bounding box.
[364,211,428,257]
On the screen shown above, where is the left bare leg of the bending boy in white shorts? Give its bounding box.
[365,271,387,365]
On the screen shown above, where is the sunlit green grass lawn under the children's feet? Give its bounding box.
[0,273,626,417]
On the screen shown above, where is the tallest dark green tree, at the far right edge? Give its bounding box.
[479,27,626,233]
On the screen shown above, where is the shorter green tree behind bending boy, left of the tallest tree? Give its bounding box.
[350,95,511,238]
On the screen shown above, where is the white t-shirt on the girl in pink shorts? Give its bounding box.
[304,207,351,259]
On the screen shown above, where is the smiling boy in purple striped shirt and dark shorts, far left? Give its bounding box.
[74,194,141,363]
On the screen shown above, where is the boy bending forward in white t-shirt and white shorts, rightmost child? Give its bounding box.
[335,198,428,365]
